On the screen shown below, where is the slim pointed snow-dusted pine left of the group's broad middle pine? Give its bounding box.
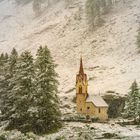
[1,48,18,119]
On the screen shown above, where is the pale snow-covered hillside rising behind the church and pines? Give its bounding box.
[0,0,140,112]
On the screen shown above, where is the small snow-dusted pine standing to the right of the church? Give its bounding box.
[125,81,140,120]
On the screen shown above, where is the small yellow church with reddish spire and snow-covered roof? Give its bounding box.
[76,58,108,121]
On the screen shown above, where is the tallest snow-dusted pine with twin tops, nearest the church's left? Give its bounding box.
[36,46,61,133]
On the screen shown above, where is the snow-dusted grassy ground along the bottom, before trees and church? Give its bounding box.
[0,122,140,140]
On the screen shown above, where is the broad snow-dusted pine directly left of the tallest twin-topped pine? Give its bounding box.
[7,51,35,132]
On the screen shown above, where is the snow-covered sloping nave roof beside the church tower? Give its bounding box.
[86,95,108,107]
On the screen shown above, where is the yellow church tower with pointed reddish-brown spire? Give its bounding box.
[76,58,88,114]
